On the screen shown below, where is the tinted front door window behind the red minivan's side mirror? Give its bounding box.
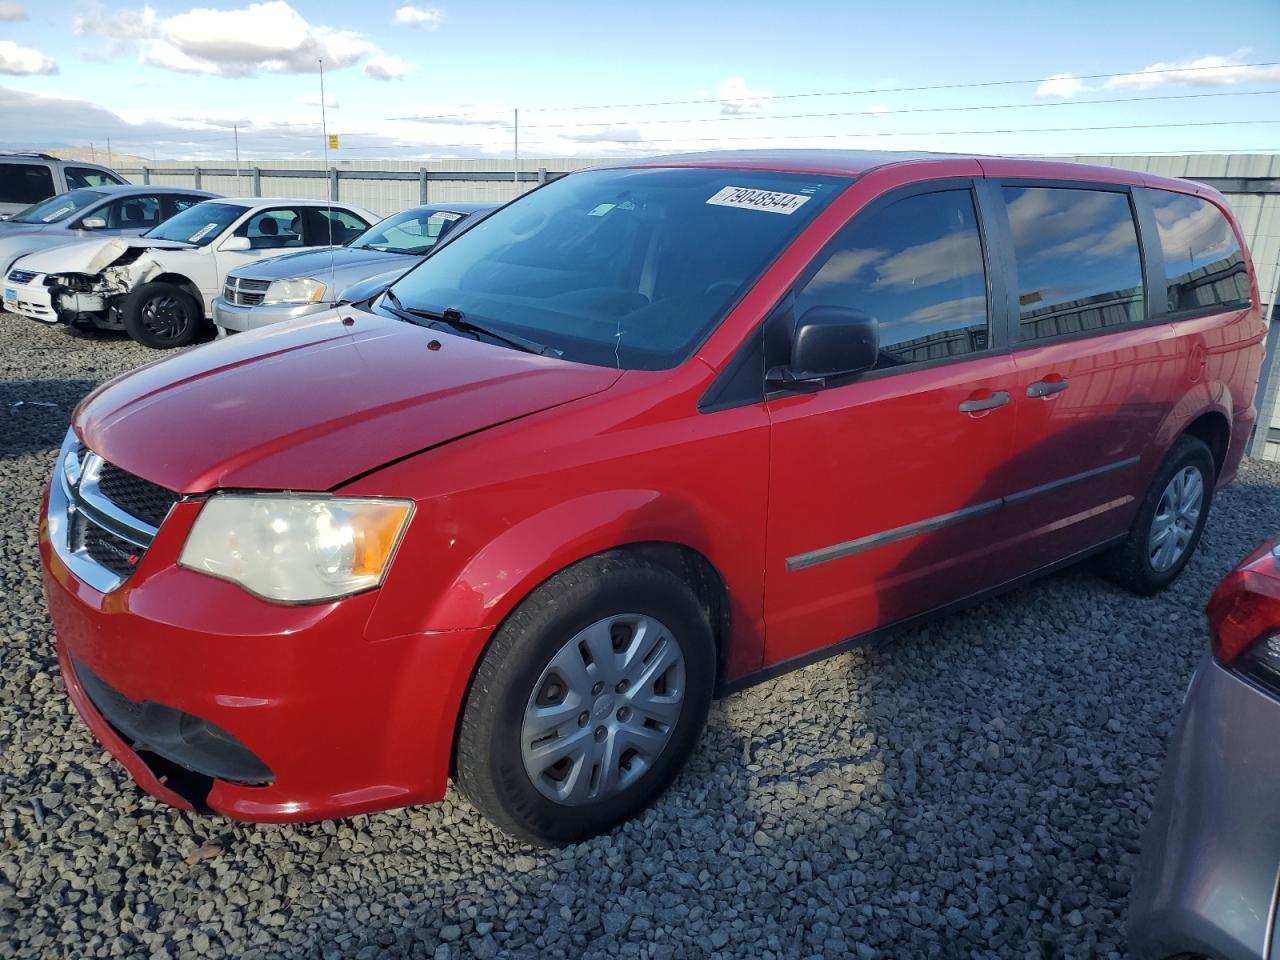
[796,189,988,369]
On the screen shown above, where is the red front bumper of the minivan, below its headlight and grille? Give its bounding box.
[40,491,489,822]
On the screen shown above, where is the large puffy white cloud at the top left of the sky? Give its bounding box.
[72,0,378,77]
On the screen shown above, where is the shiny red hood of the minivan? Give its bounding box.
[73,308,621,493]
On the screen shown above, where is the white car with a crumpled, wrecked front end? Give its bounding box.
[4,197,378,348]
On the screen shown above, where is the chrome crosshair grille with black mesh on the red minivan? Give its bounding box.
[49,431,179,593]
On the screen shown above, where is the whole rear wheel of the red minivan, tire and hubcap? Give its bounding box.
[1102,435,1216,594]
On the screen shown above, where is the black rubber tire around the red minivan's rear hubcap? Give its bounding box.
[1098,434,1217,596]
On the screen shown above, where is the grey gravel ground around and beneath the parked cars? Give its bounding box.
[0,316,1280,960]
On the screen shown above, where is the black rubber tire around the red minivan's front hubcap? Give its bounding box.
[456,550,716,846]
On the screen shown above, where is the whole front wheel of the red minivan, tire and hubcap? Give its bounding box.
[457,553,716,845]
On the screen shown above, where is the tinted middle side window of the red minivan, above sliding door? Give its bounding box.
[1005,187,1146,340]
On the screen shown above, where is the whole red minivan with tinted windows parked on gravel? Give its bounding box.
[41,151,1265,842]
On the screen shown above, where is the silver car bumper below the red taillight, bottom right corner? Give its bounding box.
[1129,658,1280,960]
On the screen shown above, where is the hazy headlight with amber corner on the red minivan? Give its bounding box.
[178,494,413,603]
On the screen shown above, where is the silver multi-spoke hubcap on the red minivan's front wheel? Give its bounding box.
[520,613,685,806]
